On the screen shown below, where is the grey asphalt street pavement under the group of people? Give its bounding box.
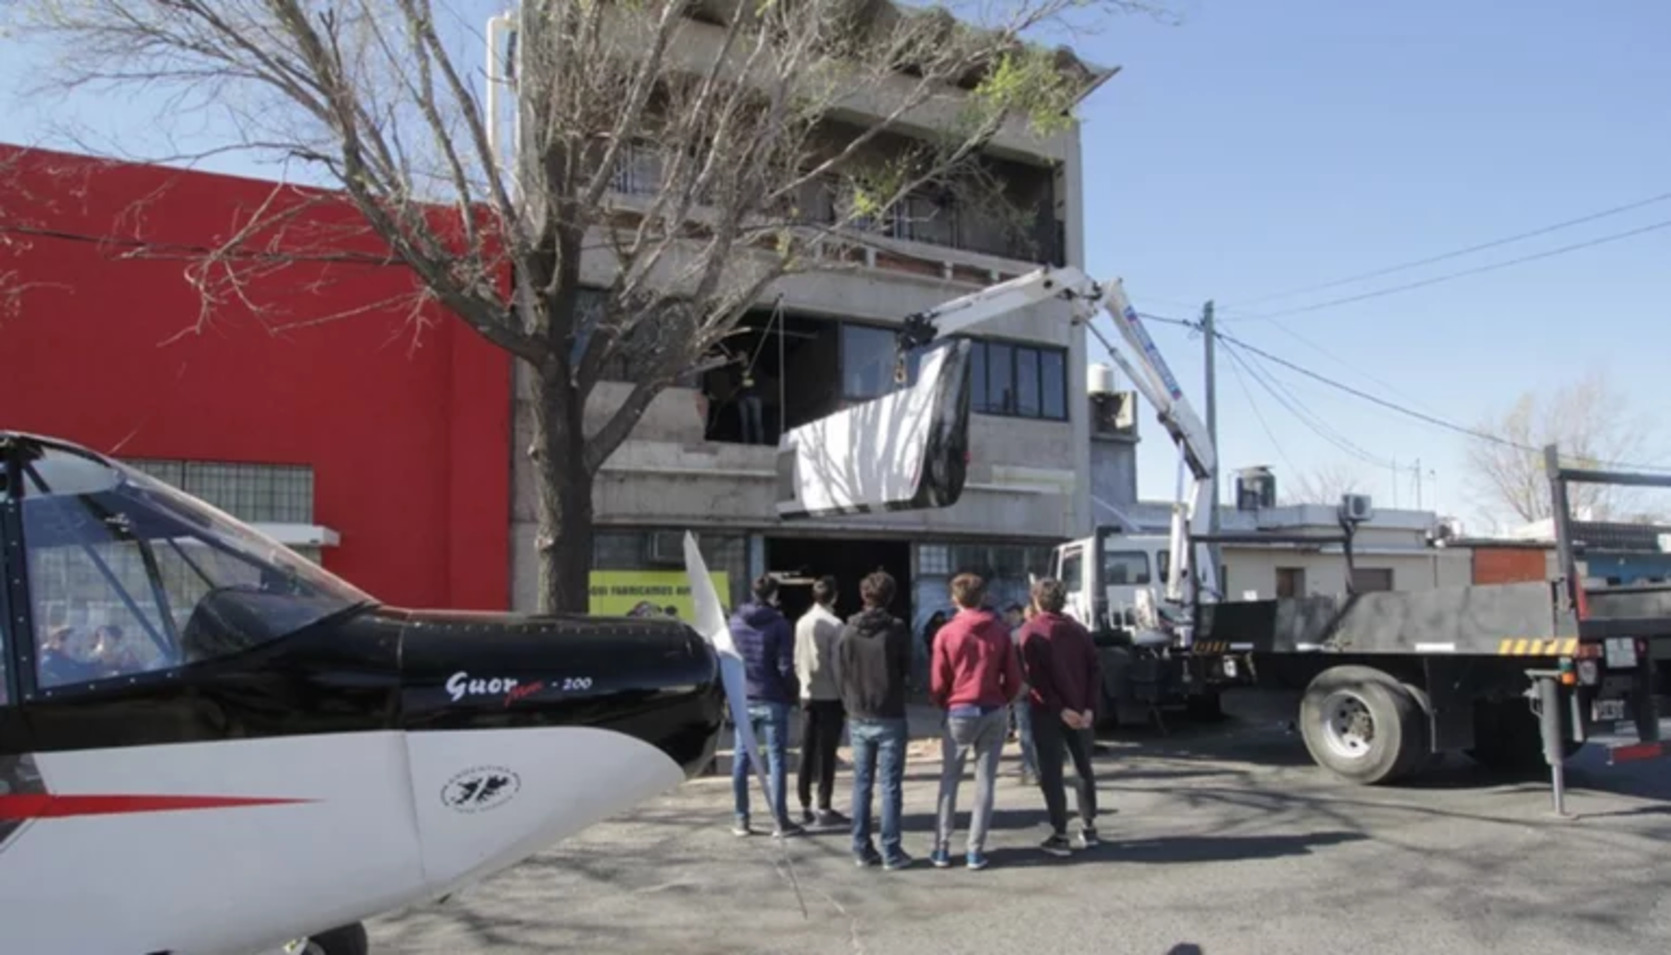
[369,721,1671,955]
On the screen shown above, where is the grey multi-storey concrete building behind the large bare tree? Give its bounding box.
[511,9,1116,626]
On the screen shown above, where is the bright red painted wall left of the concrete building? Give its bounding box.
[0,147,511,609]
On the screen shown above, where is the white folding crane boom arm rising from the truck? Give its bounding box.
[899,267,1218,601]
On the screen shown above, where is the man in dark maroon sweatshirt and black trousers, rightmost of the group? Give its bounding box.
[1021,578,1103,856]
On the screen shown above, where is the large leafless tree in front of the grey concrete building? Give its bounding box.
[9,0,1148,609]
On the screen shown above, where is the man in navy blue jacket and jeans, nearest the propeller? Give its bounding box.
[730,576,800,838]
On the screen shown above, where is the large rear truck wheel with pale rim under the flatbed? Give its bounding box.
[1300,666,1424,786]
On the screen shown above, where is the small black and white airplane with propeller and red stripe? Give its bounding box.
[0,431,765,955]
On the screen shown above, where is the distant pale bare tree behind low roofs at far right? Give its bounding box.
[1467,371,1653,526]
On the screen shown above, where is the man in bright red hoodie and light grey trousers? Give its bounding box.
[929,574,1021,868]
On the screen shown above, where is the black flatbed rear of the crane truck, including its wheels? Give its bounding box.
[1183,446,1671,794]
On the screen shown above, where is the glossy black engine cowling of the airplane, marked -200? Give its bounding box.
[401,611,725,776]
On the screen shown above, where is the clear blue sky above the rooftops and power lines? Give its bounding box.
[0,0,1671,530]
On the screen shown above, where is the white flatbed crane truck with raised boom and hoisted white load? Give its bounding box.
[777,258,1671,798]
